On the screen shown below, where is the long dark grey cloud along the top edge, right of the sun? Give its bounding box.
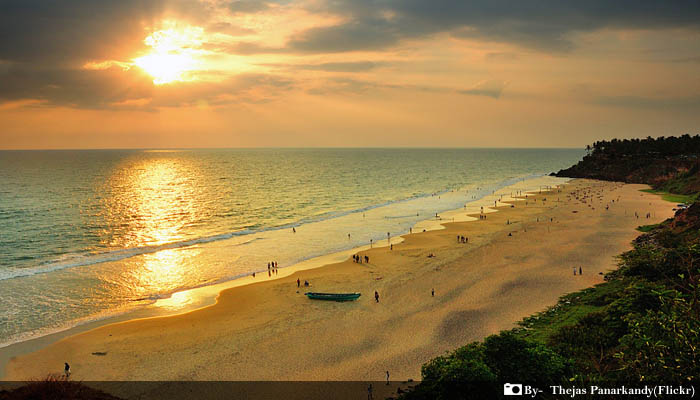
[289,0,700,52]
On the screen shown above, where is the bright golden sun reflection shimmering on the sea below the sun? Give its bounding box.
[104,156,204,300]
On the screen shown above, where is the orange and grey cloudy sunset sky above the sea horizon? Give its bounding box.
[0,0,700,149]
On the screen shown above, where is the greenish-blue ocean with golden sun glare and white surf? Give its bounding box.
[0,149,584,347]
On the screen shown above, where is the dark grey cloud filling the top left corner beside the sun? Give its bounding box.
[0,0,209,67]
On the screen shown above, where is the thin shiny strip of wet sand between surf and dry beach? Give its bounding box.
[0,175,556,366]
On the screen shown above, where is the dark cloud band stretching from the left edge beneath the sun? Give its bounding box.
[0,60,293,110]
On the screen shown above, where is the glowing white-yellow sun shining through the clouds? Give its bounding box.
[133,22,203,85]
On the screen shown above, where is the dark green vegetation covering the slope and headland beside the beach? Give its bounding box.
[403,135,700,399]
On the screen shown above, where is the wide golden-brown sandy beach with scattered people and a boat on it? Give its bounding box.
[0,180,674,390]
